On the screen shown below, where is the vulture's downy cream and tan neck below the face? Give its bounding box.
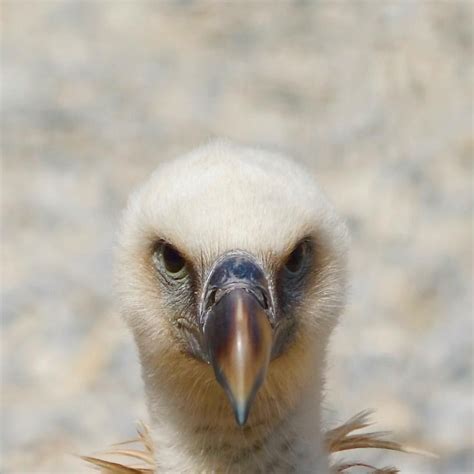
[145,354,329,474]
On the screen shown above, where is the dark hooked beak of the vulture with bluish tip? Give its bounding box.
[203,254,273,426]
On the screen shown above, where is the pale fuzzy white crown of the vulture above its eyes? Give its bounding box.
[121,141,347,266]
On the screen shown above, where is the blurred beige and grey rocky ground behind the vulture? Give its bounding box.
[1,0,474,473]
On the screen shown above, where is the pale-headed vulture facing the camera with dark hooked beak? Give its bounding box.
[84,141,422,474]
